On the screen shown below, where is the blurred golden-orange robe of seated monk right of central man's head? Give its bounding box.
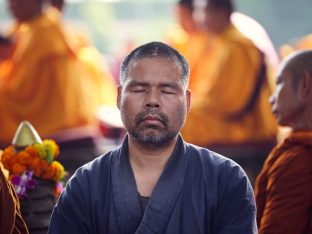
[182,25,277,146]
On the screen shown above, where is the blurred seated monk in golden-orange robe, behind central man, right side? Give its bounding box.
[182,0,277,185]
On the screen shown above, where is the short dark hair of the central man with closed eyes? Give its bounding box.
[119,41,190,88]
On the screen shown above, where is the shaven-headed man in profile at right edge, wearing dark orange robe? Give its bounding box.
[255,50,312,234]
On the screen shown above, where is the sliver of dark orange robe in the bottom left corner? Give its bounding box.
[0,162,28,234]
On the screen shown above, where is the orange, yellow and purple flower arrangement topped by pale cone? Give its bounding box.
[0,121,65,198]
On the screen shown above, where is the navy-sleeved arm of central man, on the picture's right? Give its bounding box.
[212,162,257,234]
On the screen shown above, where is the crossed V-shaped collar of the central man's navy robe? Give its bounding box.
[112,135,189,233]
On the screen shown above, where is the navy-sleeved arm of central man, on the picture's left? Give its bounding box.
[48,170,92,234]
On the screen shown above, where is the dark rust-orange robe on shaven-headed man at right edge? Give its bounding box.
[255,131,312,234]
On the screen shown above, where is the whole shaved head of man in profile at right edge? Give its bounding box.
[270,50,312,130]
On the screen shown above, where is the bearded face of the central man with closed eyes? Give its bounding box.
[117,58,190,146]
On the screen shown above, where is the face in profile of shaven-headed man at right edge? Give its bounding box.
[270,65,303,127]
